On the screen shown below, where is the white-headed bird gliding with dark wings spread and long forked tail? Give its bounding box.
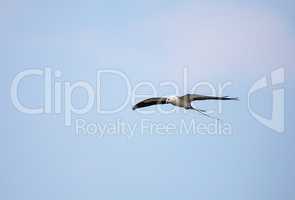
[132,94,239,118]
